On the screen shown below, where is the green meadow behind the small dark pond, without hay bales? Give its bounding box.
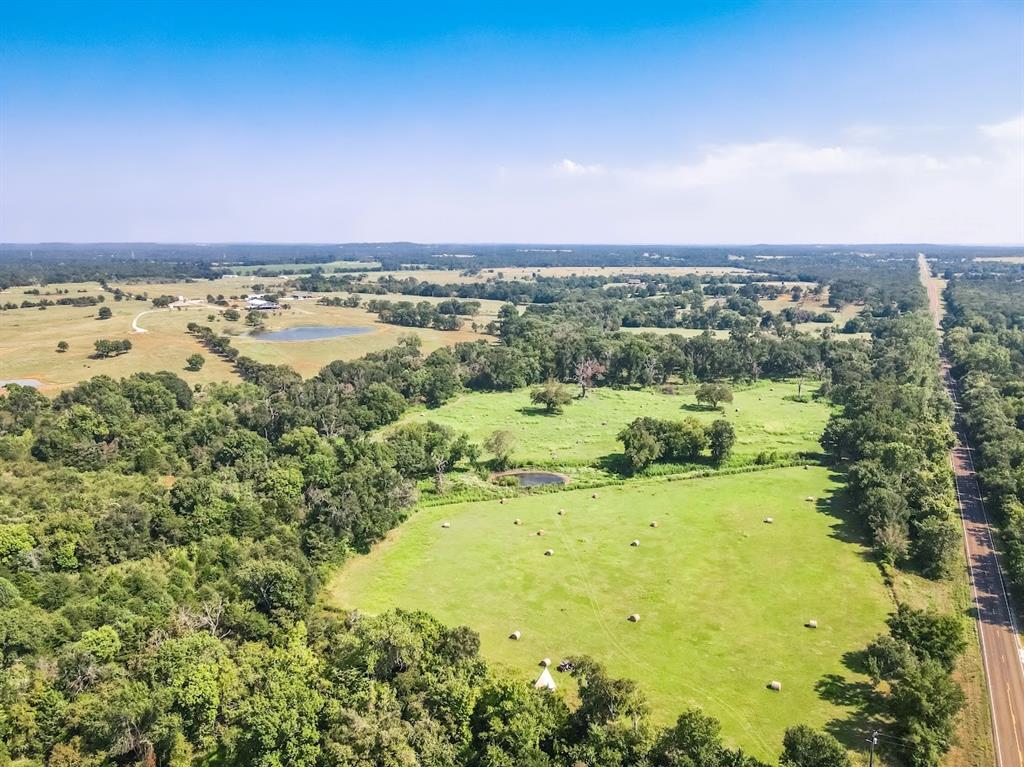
[402,381,830,466]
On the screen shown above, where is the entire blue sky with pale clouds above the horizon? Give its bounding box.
[0,0,1024,243]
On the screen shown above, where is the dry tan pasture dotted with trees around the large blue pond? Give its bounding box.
[0,276,501,393]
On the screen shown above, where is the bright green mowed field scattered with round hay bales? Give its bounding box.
[326,468,891,759]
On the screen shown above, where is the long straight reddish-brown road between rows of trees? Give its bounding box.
[919,256,1024,767]
